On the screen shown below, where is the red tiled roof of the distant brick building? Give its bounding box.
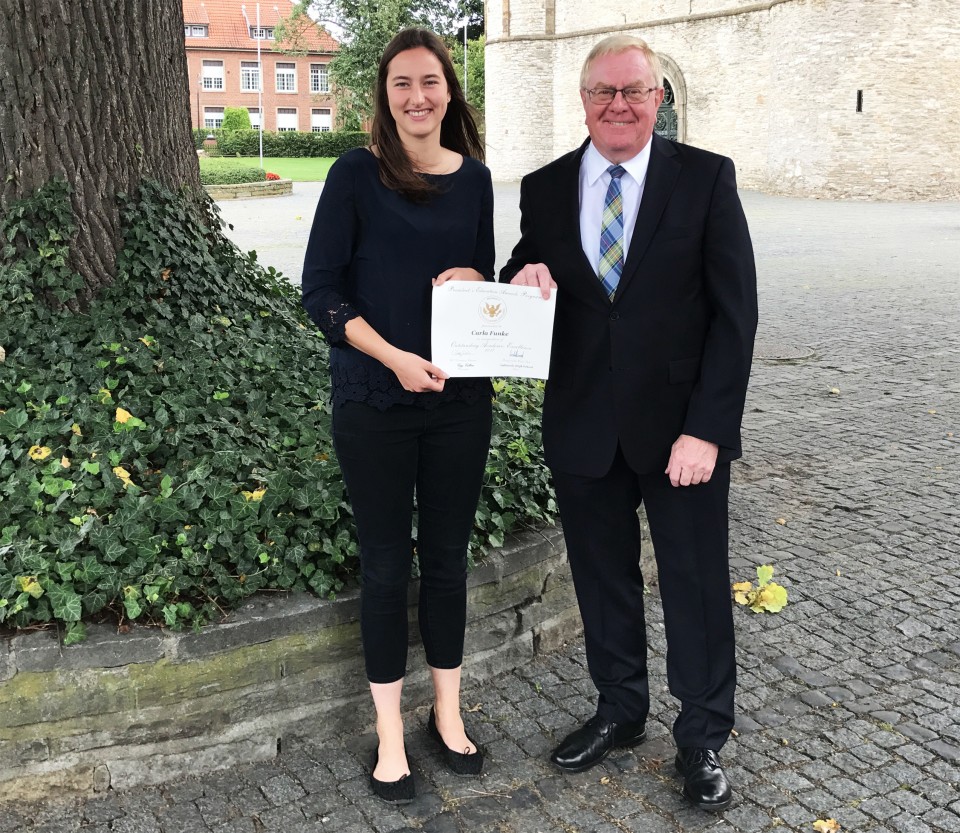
[183,0,339,52]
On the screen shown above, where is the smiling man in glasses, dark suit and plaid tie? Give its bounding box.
[500,36,757,810]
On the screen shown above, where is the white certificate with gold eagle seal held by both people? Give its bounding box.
[431,281,557,379]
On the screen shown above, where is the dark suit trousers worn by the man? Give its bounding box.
[553,448,736,749]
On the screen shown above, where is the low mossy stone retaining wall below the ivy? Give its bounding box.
[0,529,580,802]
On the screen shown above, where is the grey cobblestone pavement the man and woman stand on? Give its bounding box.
[16,185,960,833]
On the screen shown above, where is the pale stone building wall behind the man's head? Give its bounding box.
[486,0,960,199]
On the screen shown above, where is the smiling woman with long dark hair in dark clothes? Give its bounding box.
[303,29,494,803]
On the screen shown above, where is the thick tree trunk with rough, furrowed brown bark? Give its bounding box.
[0,0,199,302]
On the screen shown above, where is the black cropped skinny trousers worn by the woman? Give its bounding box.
[333,397,492,683]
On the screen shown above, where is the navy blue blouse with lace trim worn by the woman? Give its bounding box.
[302,148,494,410]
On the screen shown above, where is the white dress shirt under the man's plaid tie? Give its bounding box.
[580,138,652,278]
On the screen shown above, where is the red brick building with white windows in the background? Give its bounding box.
[183,0,338,132]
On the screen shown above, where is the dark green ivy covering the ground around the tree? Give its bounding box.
[0,177,555,644]
